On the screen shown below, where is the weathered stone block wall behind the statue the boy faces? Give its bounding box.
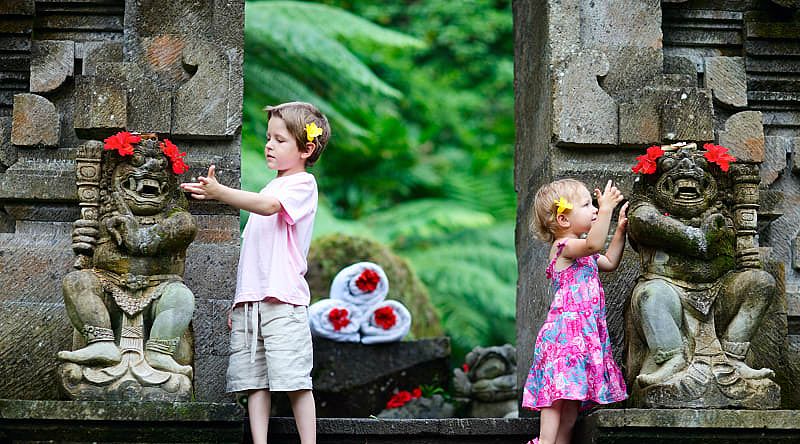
[0,0,244,401]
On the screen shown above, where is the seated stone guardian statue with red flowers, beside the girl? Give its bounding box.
[626,144,780,409]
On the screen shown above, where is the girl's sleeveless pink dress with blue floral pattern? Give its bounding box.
[522,241,628,410]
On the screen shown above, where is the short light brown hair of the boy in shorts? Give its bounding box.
[264,102,331,167]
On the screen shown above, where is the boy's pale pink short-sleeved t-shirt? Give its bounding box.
[234,172,317,305]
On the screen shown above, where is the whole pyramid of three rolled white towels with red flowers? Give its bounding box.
[308,262,411,344]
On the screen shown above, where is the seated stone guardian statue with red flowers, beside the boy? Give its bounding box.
[58,133,197,401]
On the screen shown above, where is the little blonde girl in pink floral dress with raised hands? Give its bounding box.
[522,179,628,444]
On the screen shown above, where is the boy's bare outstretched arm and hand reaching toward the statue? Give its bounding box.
[181,165,281,216]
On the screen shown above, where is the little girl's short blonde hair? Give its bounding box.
[531,179,586,242]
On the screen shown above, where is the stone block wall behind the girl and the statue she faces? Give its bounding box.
[513,0,800,408]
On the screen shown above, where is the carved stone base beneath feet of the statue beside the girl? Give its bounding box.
[631,372,781,410]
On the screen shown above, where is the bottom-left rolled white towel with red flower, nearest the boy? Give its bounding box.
[308,299,361,342]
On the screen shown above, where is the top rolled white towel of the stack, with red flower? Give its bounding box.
[330,262,389,321]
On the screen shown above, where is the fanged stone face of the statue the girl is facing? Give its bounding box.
[655,149,717,218]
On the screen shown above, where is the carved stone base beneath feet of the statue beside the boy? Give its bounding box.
[58,362,192,402]
